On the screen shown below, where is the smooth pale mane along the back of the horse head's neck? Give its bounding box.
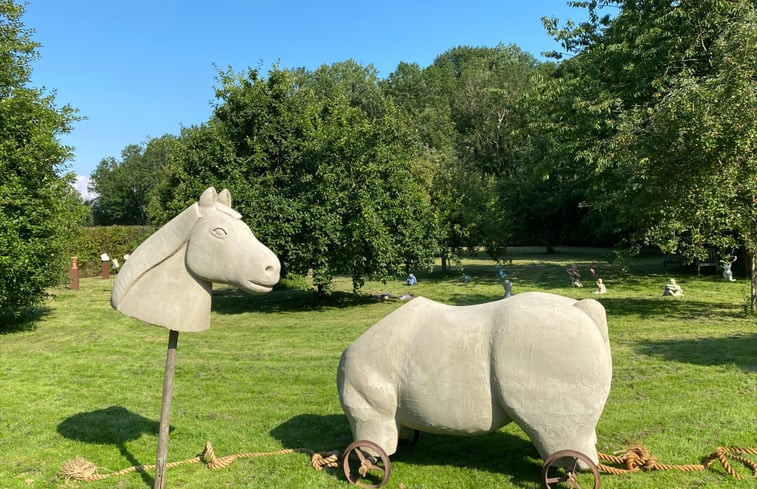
[110,202,200,309]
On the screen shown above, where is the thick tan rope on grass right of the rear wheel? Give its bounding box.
[597,445,757,480]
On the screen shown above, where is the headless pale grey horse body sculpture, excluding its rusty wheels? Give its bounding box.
[337,292,612,464]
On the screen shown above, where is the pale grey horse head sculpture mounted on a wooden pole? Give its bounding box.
[110,187,281,331]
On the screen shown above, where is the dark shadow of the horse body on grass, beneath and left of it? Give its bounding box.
[271,414,541,483]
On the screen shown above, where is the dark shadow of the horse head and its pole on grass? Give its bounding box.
[57,406,173,487]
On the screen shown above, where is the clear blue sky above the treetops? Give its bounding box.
[23,0,585,194]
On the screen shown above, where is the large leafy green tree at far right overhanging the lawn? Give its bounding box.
[548,0,757,311]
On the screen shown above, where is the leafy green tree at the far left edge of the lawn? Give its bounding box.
[0,0,82,320]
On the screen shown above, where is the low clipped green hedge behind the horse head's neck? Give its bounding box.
[68,226,156,277]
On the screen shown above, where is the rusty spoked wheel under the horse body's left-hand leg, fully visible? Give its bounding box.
[342,440,392,487]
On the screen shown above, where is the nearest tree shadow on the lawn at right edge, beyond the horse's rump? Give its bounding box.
[638,333,757,372]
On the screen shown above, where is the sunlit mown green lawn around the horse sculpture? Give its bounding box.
[0,248,757,489]
